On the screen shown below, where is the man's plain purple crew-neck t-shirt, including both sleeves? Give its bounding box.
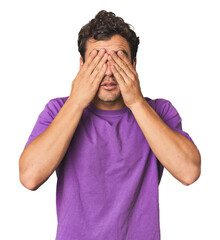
[25,97,192,240]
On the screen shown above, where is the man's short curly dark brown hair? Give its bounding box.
[78,10,140,62]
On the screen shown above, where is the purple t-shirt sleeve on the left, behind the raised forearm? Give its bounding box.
[24,99,62,148]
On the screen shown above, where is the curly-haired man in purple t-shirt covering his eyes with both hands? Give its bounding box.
[19,11,201,240]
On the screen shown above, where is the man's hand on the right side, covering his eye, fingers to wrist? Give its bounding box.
[108,51,144,108]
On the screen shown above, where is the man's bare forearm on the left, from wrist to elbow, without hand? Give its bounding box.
[19,98,83,190]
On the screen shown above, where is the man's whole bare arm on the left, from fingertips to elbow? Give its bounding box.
[19,51,107,190]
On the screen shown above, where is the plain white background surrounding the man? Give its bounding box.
[0,0,220,240]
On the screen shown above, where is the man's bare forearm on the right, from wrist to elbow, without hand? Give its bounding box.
[130,99,201,185]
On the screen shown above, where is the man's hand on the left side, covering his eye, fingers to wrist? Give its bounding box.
[69,49,108,109]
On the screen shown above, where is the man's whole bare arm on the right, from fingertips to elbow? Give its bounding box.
[109,51,201,185]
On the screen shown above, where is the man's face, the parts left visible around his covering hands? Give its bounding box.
[80,35,135,104]
